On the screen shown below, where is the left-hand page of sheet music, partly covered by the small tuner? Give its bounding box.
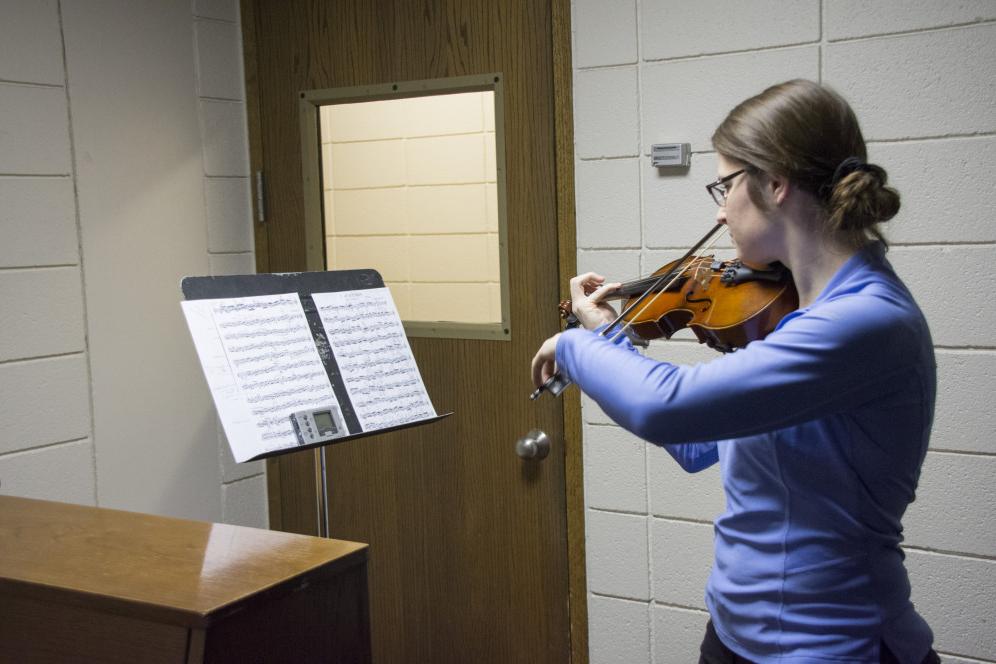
[181,293,339,461]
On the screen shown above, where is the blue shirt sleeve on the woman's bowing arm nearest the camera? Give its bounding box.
[557,295,919,452]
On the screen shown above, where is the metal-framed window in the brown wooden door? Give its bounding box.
[302,75,510,338]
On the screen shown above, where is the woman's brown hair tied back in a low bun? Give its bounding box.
[712,79,899,247]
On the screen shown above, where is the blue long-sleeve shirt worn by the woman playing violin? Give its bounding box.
[557,244,936,664]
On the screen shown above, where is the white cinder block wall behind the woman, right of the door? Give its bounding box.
[573,0,996,664]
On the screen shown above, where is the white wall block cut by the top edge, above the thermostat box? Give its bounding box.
[640,0,820,61]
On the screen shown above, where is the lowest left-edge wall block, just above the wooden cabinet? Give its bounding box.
[0,440,96,505]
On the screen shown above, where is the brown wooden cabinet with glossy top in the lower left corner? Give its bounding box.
[0,496,370,664]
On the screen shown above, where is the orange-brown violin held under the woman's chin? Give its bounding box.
[530,224,799,399]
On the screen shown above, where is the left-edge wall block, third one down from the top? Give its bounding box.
[0,178,79,267]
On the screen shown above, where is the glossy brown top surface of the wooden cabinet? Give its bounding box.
[0,496,366,616]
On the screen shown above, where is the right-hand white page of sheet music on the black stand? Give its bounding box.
[311,288,436,431]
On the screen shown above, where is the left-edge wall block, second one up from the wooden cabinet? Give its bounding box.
[0,355,92,454]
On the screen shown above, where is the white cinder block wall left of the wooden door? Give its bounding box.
[0,0,267,527]
